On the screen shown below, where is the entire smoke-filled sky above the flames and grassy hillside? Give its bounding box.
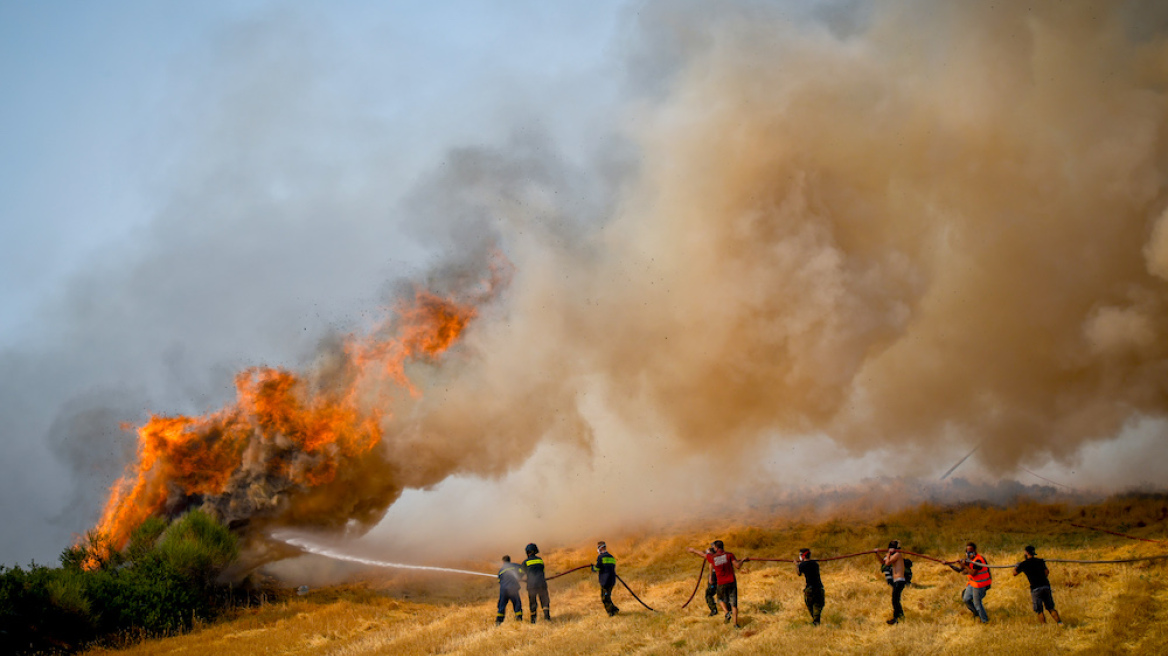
[0,0,1168,564]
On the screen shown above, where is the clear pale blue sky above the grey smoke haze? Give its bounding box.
[0,0,620,343]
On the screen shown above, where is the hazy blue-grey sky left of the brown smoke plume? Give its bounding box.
[0,0,621,563]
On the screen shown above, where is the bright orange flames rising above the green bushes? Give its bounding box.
[83,289,477,565]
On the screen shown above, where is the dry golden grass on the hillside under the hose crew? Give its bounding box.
[90,497,1168,656]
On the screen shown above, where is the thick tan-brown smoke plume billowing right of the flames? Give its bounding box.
[424,2,1168,473]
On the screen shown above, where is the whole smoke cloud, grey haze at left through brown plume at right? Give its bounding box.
[0,2,1168,560]
